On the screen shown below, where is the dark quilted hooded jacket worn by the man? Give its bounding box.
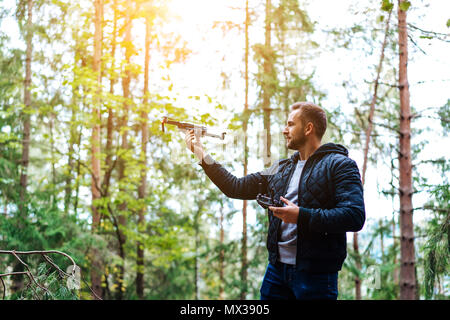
[200,143,365,272]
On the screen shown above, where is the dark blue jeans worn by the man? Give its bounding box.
[260,262,338,300]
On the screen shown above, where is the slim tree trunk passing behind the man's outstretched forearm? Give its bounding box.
[241,0,250,300]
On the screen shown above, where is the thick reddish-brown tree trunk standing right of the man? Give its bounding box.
[398,0,416,300]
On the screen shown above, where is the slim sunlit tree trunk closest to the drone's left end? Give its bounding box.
[136,18,151,299]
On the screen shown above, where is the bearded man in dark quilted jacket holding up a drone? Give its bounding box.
[185,102,365,300]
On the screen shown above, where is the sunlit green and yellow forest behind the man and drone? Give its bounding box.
[0,0,450,300]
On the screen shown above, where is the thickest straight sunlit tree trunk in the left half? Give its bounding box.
[91,0,103,302]
